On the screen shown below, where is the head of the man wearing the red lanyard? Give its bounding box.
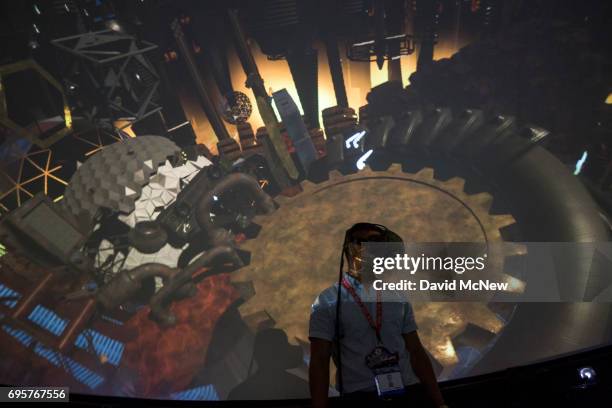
[343,222,402,280]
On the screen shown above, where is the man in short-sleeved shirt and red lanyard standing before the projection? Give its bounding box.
[309,223,446,408]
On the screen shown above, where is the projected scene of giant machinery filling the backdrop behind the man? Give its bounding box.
[0,0,612,401]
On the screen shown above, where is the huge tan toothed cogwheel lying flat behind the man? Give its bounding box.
[232,164,523,367]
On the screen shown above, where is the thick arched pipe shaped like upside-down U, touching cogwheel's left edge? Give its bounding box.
[195,173,276,247]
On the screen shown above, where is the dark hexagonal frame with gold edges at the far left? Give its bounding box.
[0,60,72,149]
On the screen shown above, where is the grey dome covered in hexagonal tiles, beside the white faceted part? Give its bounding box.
[62,136,180,219]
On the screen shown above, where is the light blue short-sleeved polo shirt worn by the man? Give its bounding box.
[309,274,417,393]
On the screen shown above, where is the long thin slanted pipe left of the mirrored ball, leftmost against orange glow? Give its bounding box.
[171,20,231,141]
